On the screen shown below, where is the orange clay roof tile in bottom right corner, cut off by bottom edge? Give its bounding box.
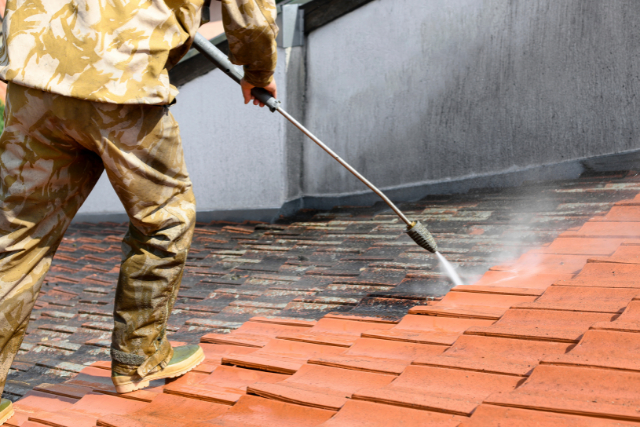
[459,404,638,427]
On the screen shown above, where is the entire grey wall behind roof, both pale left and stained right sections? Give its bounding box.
[81,0,640,219]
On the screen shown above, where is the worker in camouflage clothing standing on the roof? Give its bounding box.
[0,0,278,423]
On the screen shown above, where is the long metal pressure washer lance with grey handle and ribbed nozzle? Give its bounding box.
[193,34,438,253]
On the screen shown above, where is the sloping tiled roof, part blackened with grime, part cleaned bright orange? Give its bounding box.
[4,172,640,427]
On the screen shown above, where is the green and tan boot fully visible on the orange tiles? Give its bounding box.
[111,345,204,394]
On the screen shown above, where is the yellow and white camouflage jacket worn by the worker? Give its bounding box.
[0,0,278,104]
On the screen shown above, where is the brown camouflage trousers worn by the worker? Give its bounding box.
[0,83,195,391]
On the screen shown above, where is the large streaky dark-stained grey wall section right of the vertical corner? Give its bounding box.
[303,0,640,196]
